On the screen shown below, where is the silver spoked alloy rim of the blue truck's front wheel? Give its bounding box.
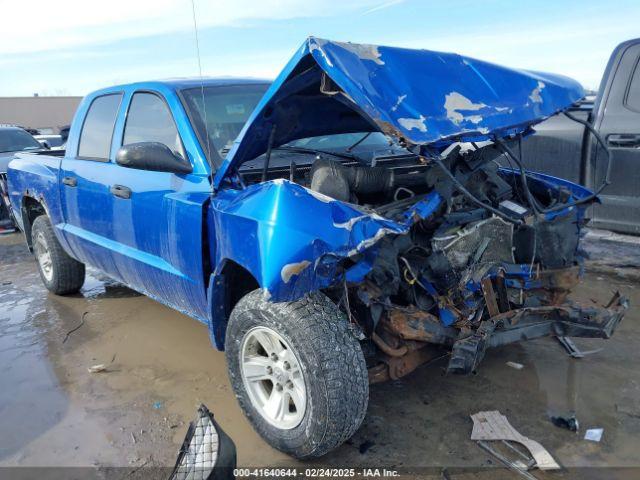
[240,327,307,430]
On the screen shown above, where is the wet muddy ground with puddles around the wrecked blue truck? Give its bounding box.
[0,234,640,478]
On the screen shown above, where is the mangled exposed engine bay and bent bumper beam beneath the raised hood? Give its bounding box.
[240,140,626,382]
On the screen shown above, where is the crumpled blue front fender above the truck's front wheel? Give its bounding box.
[210,179,442,302]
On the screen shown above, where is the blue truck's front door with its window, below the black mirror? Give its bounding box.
[109,91,211,320]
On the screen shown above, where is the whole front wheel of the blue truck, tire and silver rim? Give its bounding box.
[225,290,369,458]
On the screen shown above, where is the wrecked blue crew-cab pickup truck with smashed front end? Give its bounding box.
[3,38,627,458]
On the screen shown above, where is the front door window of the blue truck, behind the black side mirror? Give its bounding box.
[122,92,185,158]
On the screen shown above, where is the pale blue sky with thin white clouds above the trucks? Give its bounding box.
[0,0,640,96]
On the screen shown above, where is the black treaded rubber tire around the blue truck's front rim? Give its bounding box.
[225,290,369,459]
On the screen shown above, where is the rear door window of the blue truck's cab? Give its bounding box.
[78,93,122,162]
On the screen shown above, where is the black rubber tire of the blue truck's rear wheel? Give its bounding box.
[31,215,85,295]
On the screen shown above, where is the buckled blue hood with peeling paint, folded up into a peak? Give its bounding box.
[215,37,584,187]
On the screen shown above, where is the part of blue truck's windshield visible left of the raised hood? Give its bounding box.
[182,84,269,158]
